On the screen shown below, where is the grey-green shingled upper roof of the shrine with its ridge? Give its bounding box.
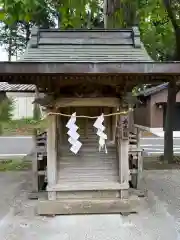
[20,27,152,63]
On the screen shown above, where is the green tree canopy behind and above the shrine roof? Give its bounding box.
[0,0,180,61]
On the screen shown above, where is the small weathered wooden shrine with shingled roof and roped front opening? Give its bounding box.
[0,27,180,214]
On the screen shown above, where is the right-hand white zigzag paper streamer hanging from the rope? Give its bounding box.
[93,114,107,153]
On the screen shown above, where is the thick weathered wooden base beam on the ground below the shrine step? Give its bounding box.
[37,198,140,215]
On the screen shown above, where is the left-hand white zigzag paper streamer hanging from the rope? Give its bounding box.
[66,113,82,154]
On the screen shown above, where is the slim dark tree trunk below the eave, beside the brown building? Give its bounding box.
[164,81,176,163]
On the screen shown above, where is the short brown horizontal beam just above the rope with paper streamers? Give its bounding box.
[53,97,120,108]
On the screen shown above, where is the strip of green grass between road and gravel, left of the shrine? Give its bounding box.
[0,159,31,172]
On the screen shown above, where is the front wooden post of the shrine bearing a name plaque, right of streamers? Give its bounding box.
[118,116,129,199]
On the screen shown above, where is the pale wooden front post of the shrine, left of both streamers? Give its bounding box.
[47,115,57,200]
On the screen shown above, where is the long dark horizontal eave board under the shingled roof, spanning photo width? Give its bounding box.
[0,61,180,76]
